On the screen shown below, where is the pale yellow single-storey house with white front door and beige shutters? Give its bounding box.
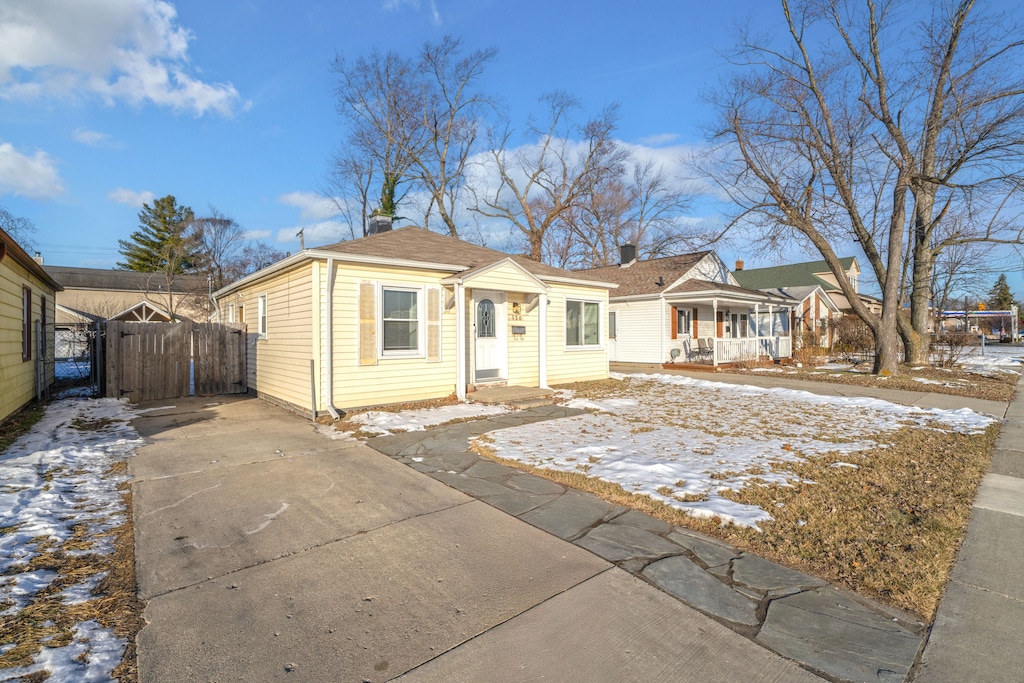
[214,227,615,415]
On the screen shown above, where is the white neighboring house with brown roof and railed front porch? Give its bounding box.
[579,245,796,366]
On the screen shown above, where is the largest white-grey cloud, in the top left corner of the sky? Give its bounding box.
[0,0,241,116]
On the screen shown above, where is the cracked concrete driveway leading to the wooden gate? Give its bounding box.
[131,398,820,683]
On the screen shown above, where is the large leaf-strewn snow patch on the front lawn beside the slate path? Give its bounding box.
[475,375,994,527]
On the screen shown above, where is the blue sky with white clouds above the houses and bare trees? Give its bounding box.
[0,0,1024,296]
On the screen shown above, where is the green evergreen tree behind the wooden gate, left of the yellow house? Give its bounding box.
[118,195,196,275]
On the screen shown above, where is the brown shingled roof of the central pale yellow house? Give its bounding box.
[316,225,615,283]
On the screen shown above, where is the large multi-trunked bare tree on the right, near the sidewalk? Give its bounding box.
[705,0,1024,373]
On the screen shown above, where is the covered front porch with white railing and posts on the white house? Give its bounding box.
[667,283,796,368]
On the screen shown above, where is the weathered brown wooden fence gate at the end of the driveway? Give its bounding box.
[100,321,248,402]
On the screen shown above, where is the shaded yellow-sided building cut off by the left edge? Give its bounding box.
[0,229,60,420]
